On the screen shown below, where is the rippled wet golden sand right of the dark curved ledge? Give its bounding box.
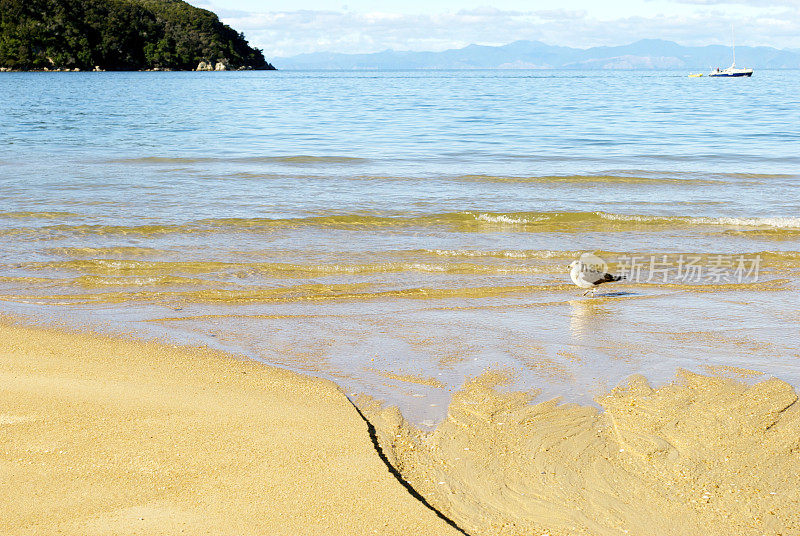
[362,373,800,536]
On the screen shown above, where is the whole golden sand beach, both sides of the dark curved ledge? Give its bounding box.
[6,316,800,536]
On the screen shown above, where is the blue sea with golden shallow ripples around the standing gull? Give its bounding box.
[0,71,800,422]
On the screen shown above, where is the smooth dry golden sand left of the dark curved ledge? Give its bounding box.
[0,324,457,536]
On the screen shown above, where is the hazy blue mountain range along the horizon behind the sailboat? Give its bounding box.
[273,39,800,70]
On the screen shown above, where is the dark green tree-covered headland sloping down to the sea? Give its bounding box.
[0,0,272,70]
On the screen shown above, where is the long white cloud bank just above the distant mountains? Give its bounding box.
[220,0,800,58]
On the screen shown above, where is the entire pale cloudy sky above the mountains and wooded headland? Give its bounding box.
[195,0,800,58]
